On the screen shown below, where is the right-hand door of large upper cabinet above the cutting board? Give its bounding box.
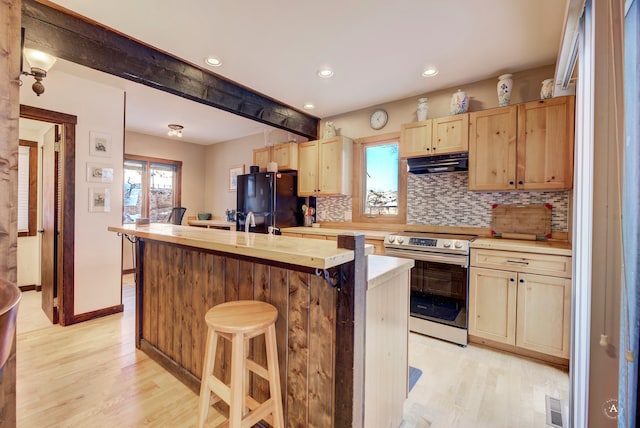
[517,96,574,190]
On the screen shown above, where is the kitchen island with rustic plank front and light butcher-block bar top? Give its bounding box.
[109,224,413,427]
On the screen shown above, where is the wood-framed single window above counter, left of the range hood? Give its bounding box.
[353,134,407,223]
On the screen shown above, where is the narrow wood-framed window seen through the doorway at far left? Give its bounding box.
[18,140,38,236]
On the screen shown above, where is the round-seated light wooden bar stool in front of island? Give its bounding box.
[198,300,284,428]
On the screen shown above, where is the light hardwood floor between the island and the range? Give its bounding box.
[405,333,569,428]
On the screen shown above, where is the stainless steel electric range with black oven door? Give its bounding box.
[384,232,475,345]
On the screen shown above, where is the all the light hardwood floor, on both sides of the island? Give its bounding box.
[17,275,569,428]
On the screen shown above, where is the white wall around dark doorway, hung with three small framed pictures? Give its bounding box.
[20,66,124,315]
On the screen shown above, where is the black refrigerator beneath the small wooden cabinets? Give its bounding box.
[236,172,304,233]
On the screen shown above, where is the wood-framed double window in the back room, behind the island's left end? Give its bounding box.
[122,155,182,223]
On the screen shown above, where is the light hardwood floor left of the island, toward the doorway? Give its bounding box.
[16,276,224,428]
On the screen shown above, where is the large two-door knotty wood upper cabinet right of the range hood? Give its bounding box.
[469,96,574,190]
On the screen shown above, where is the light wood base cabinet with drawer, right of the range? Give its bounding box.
[469,249,571,359]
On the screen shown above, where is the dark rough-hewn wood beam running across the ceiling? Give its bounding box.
[22,0,319,139]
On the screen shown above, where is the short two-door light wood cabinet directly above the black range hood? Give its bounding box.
[400,113,469,158]
